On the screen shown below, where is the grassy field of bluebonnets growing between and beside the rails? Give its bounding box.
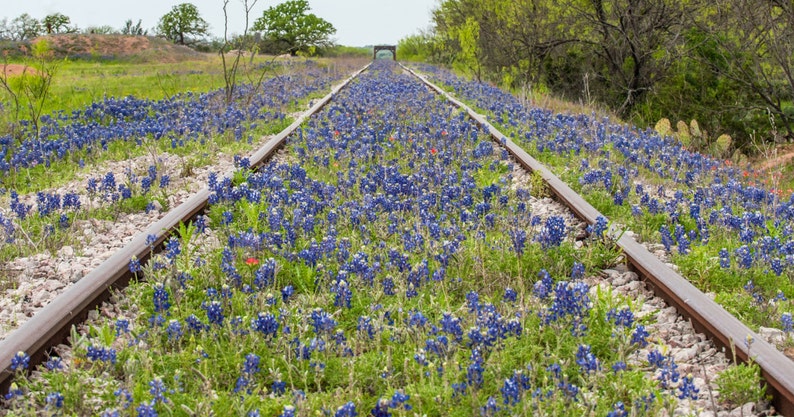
[0,37,794,416]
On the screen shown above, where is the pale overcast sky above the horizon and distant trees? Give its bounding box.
[0,0,439,46]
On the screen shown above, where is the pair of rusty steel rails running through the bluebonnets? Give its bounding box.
[0,60,794,416]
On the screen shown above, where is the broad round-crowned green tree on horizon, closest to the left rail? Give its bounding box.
[252,0,336,56]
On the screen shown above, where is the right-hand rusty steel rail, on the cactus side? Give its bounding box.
[400,64,794,416]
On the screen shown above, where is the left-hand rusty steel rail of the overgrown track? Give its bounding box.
[0,63,372,394]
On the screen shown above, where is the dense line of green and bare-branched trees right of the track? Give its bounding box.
[399,0,794,152]
